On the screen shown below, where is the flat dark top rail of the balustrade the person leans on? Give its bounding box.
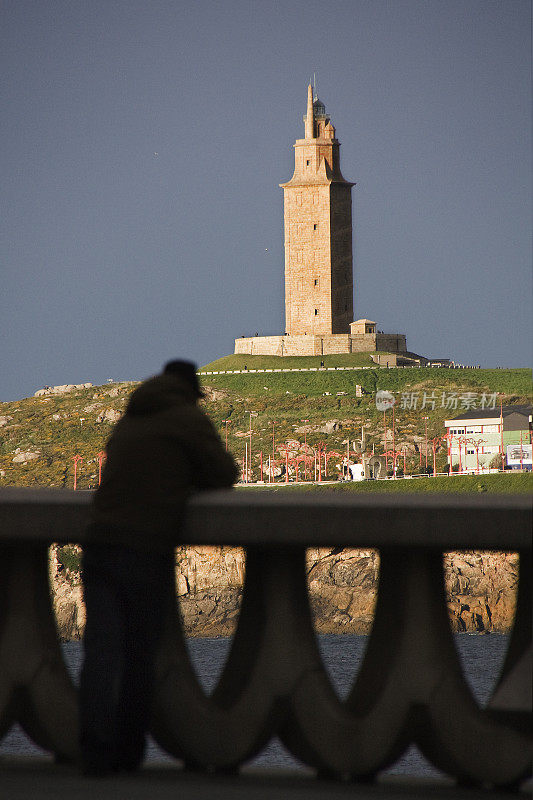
[0,488,532,550]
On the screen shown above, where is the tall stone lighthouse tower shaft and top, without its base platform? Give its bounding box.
[280,85,354,336]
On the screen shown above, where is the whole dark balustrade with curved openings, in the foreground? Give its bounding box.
[0,489,532,786]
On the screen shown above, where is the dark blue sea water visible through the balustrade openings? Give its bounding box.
[0,634,508,776]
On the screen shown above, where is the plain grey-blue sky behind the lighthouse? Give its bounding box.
[0,0,532,400]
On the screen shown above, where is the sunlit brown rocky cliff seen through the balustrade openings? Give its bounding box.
[50,547,518,639]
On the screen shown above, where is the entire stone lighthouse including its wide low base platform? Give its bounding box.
[235,84,414,358]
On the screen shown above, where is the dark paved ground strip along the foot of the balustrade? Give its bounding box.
[0,758,531,800]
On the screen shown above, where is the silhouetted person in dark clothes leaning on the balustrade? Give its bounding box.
[80,361,237,775]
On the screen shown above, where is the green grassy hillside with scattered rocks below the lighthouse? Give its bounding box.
[0,360,531,491]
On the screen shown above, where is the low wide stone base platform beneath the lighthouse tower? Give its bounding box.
[235,333,407,356]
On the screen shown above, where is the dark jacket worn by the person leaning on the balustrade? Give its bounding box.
[91,375,237,551]
